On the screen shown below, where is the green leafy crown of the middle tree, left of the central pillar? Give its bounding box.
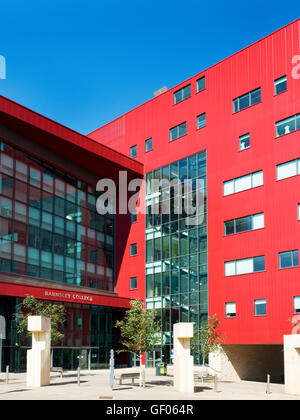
[115,299,161,353]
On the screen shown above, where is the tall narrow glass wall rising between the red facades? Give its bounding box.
[146,151,208,363]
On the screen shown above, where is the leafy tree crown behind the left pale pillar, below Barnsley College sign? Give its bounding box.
[14,295,65,344]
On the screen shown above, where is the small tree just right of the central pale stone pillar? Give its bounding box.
[191,315,224,366]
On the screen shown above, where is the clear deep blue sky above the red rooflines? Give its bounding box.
[0,0,300,134]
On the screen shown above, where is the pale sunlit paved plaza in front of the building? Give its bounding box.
[0,368,300,402]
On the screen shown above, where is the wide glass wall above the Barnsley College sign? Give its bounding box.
[0,142,115,291]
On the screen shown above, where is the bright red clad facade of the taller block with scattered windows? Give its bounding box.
[89,20,300,378]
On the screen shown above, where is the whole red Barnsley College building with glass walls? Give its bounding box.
[0,20,300,380]
